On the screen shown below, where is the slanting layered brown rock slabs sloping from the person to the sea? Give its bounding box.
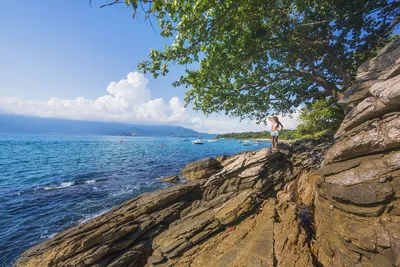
[15,137,329,267]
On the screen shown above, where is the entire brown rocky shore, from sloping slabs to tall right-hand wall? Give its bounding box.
[15,40,400,267]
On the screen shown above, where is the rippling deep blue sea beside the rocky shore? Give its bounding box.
[0,134,270,266]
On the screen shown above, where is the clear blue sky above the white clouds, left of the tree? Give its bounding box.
[0,0,184,100]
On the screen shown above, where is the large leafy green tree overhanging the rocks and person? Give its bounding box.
[100,0,400,121]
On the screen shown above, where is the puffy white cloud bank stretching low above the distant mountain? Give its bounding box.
[0,72,297,133]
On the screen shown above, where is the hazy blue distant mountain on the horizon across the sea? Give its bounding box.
[0,114,216,138]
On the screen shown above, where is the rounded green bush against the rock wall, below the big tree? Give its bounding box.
[297,99,344,135]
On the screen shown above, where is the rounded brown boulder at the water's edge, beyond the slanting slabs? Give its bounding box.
[181,158,222,180]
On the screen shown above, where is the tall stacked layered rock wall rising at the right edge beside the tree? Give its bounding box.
[315,39,400,267]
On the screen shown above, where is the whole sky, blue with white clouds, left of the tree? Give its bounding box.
[0,0,298,133]
